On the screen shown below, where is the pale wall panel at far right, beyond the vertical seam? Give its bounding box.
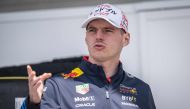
[139,2,190,109]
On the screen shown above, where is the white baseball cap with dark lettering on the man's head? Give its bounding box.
[82,3,128,32]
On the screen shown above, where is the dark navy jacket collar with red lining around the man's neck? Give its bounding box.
[79,56,125,88]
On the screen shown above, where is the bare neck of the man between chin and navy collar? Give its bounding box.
[89,57,119,78]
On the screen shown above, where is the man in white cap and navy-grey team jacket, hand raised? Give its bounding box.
[22,4,156,109]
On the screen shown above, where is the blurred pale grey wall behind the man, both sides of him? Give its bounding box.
[0,0,190,109]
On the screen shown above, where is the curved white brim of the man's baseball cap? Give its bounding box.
[81,16,121,28]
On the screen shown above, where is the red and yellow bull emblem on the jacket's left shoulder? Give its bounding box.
[61,67,83,79]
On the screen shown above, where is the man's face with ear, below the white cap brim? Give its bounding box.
[85,19,130,62]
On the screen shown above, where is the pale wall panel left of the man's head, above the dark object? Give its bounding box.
[0,9,87,67]
